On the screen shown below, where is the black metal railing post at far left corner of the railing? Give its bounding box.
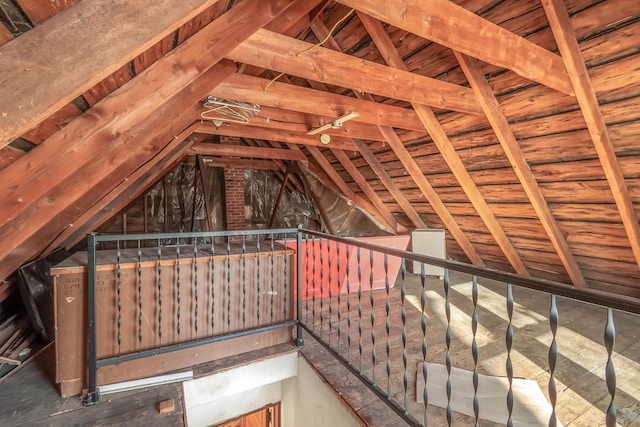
[82,233,100,406]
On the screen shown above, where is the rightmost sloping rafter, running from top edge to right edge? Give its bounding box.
[542,0,640,272]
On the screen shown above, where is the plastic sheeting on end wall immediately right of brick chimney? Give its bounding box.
[244,169,318,229]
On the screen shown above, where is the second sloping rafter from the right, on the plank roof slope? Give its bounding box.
[455,52,585,287]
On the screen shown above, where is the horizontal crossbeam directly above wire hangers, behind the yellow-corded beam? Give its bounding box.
[212,72,424,131]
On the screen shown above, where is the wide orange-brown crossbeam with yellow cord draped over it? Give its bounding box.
[227,30,481,114]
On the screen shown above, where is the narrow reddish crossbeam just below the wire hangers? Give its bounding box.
[196,122,354,150]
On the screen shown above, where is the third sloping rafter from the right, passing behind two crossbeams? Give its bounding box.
[358,12,529,276]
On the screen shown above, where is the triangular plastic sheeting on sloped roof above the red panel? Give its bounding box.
[304,166,389,237]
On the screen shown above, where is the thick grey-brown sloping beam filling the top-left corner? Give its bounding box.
[0,0,221,147]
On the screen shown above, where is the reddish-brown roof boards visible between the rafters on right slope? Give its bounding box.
[316,0,640,296]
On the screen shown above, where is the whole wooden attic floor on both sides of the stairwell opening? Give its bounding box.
[0,274,640,427]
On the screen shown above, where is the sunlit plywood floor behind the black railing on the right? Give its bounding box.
[303,273,640,426]
